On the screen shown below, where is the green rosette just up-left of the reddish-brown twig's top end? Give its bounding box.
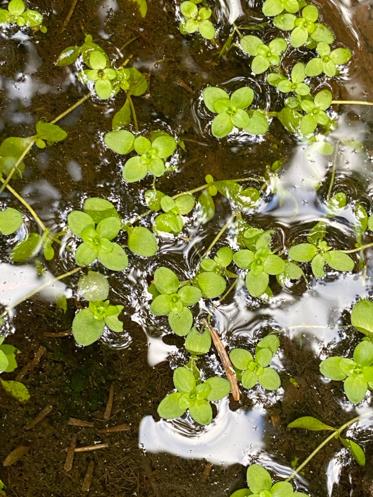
[149,267,202,336]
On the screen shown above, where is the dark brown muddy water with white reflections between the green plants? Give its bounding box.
[0,0,373,497]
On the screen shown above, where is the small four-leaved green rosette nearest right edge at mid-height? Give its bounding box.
[289,223,355,278]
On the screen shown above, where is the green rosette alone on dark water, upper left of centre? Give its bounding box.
[105,130,177,183]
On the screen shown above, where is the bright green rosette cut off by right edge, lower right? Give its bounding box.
[320,339,373,404]
